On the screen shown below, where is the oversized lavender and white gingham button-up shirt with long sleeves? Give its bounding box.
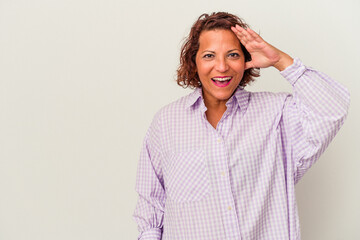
[134,59,349,240]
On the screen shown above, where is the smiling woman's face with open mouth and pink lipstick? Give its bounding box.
[196,29,245,104]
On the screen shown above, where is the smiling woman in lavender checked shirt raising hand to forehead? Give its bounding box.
[134,12,349,240]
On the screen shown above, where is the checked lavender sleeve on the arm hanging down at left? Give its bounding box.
[133,113,165,240]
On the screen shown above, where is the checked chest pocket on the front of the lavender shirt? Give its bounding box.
[166,150,210,203]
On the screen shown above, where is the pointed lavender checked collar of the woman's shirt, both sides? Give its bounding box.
[186,87,250,111]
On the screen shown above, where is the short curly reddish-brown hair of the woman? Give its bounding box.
[176,12,260,88]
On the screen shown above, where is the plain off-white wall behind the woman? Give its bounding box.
[0,0,360,240]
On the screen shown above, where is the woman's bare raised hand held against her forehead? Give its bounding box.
[231,25,293,71]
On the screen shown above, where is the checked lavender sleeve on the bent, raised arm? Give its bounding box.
[281,59,350,183]
